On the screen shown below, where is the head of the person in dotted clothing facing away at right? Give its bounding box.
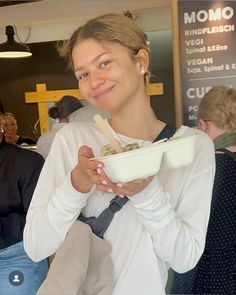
[198,86,236,151]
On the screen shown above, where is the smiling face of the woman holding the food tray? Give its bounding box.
[72,39,148,112]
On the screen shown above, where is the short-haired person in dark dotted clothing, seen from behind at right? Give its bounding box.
[171,86,236,295]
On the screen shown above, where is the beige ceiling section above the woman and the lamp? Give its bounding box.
[0,0,171,43]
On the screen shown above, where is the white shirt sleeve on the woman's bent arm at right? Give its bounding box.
[130,133,215,273]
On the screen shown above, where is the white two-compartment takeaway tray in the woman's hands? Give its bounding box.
[96,134,196,183]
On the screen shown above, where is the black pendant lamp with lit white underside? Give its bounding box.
[0,26,32,58]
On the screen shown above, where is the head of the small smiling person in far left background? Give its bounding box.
[0,113,19,144]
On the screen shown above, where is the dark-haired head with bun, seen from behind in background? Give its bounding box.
[48,95,83,123]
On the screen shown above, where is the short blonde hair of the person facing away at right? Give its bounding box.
[198,86,236,132]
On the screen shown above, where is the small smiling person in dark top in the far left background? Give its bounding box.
[0,113,36,145]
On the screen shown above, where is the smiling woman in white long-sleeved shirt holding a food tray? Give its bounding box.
[24,15,214,295]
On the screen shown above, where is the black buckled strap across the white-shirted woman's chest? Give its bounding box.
[78,124,176,238]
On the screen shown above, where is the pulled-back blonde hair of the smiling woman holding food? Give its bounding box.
[59,14,150,80]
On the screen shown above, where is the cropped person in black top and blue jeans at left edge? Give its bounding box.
[0,125,48,295]
